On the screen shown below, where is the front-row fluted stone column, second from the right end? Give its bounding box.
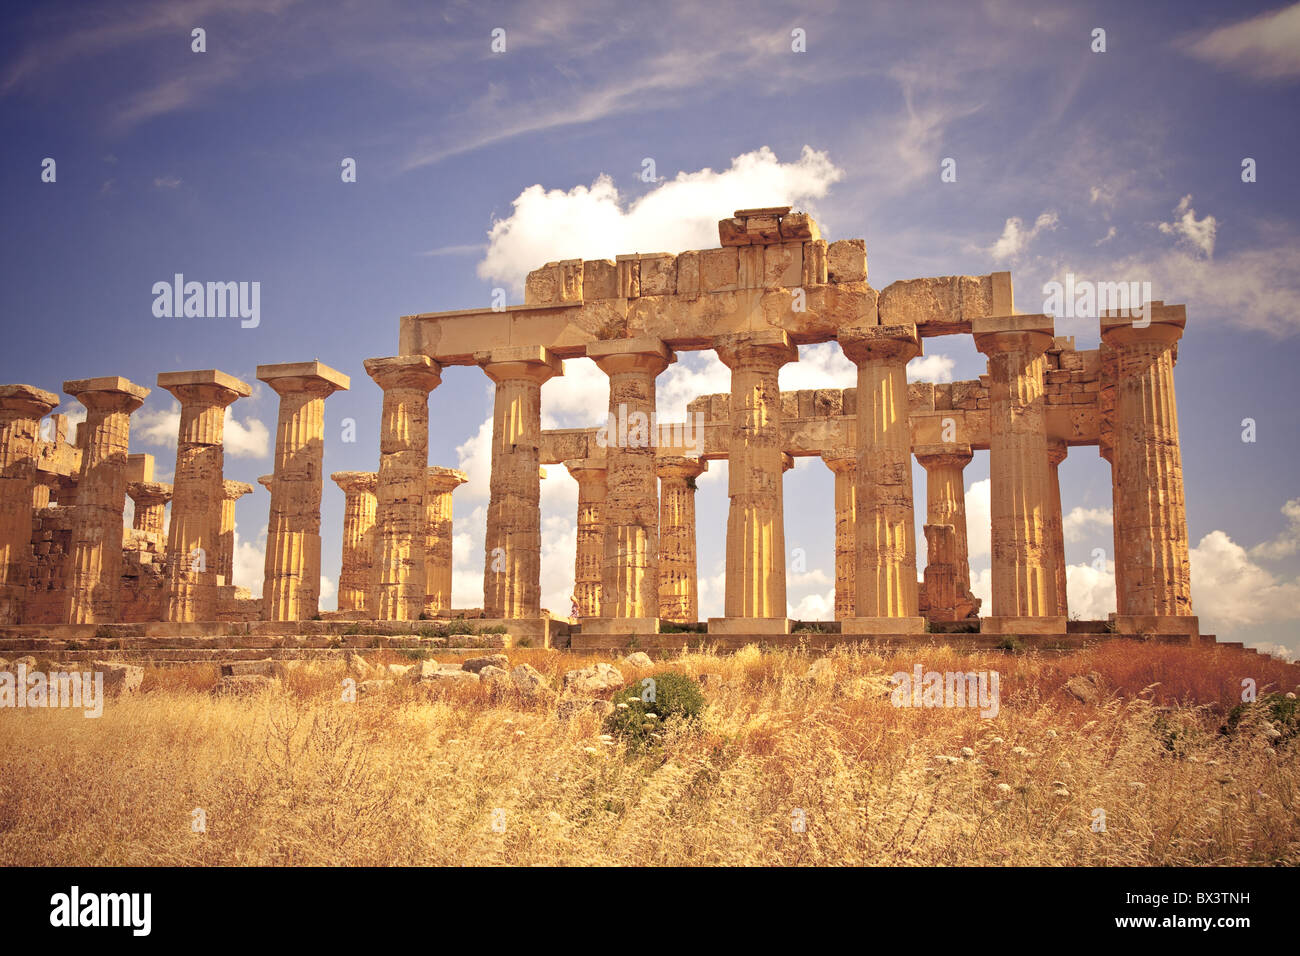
[972,315,1065,633]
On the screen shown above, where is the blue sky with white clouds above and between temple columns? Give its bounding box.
[0,1,1300,652]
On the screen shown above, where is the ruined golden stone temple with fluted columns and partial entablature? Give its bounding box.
[0,207,1197,646]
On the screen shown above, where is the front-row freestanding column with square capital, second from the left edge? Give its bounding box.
[64,377,150,624]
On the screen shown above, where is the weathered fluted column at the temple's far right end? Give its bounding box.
[1101,302,1197,637]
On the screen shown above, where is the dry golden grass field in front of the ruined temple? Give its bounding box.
[0,641,1300,865]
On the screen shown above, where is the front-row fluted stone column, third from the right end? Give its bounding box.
[839,325,926,633]
